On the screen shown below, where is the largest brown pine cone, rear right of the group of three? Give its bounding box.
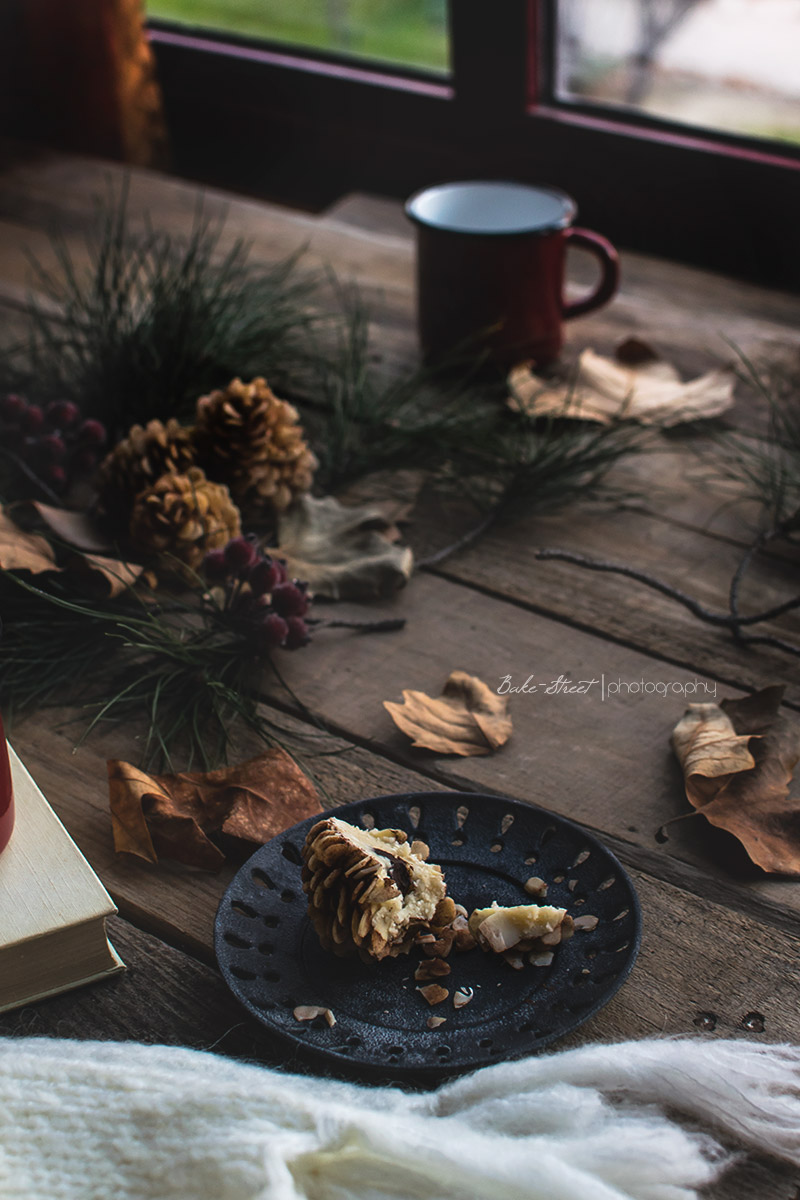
[196,378,317,512]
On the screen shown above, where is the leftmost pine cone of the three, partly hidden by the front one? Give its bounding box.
[95,418,196,532]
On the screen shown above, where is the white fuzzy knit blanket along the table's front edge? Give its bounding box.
[0,1038,800,1200]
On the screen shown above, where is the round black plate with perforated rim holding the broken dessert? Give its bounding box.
[215,792,640,1078]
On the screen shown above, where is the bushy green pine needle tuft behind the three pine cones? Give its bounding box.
[6,192,318,437]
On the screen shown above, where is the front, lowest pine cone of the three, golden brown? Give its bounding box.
[131,467,241,570]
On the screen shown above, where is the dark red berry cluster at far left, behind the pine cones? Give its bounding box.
[0,392,107,492]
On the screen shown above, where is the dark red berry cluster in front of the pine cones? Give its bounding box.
[203,538,311,655]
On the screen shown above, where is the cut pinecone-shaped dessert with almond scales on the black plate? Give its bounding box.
[302,817,456,960]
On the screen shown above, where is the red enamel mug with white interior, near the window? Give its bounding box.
[405,181,619,367]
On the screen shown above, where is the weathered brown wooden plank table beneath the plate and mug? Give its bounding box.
[0,145,800,1200]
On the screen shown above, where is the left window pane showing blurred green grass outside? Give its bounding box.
[148,0,447,71]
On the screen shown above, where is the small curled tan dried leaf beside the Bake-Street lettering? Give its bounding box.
[384,671,511,757]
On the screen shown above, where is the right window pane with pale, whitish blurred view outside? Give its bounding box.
[555,0,800,143]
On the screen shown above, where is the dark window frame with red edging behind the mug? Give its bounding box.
[150,0,800,290]
